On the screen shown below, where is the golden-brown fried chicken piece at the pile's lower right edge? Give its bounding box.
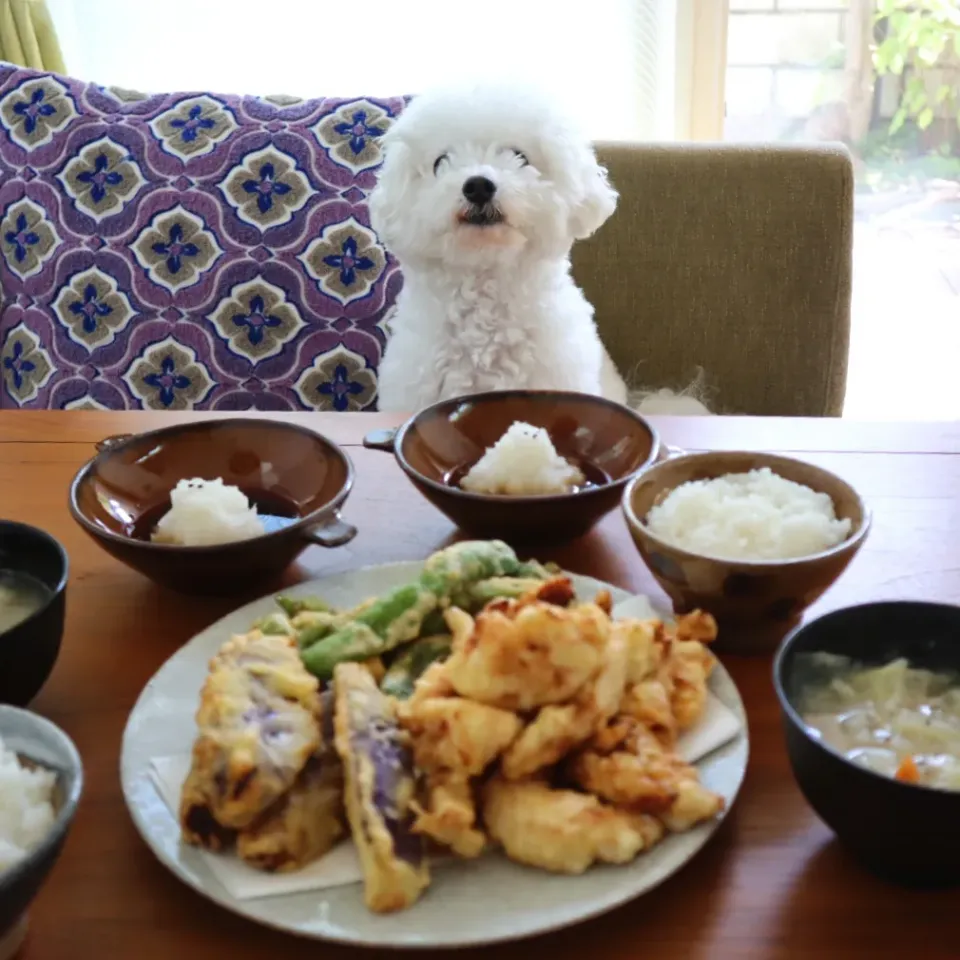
[568,721,723,830]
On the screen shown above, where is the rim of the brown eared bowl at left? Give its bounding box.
[69,417,356,555]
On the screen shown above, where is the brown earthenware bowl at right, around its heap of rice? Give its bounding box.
[623,451,870,653]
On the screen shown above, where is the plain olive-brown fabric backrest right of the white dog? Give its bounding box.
[573,144,853,416]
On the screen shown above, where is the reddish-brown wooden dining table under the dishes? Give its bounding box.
[0,411,960,960]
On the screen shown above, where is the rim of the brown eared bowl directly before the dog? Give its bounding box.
[393,390,661,506]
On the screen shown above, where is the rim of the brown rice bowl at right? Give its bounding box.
[622,450,873,571]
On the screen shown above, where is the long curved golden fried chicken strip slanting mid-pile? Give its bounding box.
[502,631,628,780]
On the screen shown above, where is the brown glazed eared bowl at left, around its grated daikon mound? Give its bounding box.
[70,419,357,594]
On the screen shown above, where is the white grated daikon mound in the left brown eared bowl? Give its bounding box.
[150,477,265,547]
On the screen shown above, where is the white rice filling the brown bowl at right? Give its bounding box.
[647,467,851,560]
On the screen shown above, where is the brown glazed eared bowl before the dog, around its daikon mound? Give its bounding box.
[364,390,660,543]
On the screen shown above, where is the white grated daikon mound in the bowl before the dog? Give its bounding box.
[460,421,585,497]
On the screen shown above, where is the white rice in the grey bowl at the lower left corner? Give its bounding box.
[0,739,57,874]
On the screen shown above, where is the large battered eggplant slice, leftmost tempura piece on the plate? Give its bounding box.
[180,630,320,850]
